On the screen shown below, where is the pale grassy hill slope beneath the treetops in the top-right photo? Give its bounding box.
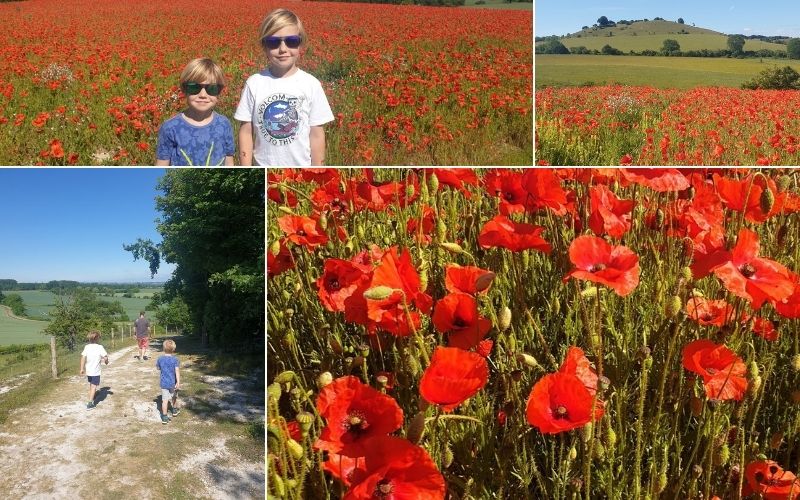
[539,21,786,52]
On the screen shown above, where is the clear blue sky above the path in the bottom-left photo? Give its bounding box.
[0,168,174,282]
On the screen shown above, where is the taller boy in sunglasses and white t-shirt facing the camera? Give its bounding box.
[234,9,333,167]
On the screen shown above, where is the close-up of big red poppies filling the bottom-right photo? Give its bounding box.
[266,168,800,500]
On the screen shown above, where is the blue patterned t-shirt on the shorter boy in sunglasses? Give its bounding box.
[156,112,235,167]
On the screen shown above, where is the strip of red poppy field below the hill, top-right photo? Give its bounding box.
[535,86,800,166]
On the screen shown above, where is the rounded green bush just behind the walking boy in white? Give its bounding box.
[44,288,128,351]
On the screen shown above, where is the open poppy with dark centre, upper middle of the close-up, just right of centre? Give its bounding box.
[564,236,639,297]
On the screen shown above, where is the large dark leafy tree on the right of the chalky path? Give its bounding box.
[123,169,265,349]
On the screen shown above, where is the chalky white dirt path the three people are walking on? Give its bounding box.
[0,343,264,500]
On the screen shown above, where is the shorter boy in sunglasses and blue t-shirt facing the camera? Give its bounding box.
[156,58,235,166]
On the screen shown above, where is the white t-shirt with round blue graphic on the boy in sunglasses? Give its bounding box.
[233,69,333,167]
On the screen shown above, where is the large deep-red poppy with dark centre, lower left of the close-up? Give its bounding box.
[314,376,403,457]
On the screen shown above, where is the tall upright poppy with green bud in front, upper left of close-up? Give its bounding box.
[367,247,433,336]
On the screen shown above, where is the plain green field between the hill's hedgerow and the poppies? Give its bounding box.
[534,54,800,89]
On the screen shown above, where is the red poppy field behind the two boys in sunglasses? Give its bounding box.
[0,0,533,165]
